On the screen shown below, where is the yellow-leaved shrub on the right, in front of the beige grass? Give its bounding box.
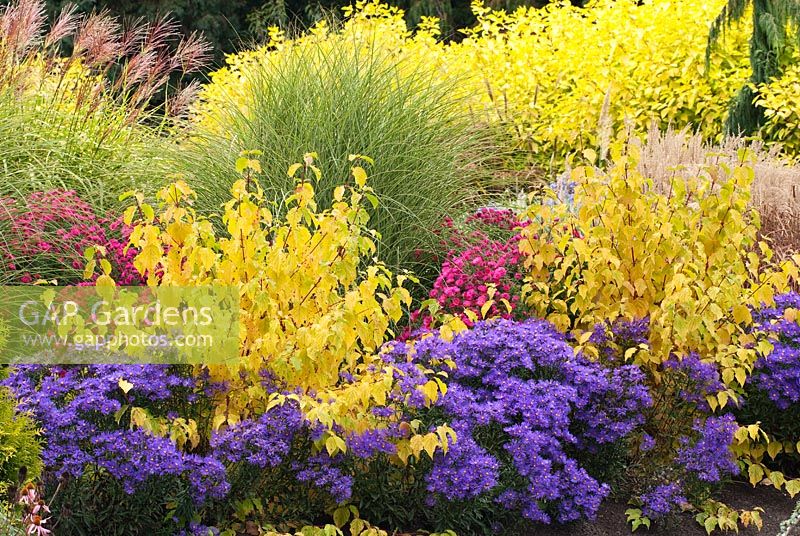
[520,132,800,494]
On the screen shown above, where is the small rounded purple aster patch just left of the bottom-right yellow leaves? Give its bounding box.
[676,413,739,482]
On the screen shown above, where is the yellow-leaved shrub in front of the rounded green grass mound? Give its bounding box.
[125,152,453,462]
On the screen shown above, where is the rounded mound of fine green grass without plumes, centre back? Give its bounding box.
[182,15,494,267]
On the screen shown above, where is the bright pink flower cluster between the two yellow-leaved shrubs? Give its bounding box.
[412,208,527,328]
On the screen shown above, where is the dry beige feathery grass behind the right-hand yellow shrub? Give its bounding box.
[639,128,800,258]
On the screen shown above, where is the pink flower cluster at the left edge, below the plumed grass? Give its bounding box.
[0,189,141,285]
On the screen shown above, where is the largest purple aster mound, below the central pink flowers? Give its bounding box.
[414,320,651,523]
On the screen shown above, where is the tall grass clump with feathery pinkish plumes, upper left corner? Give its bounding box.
[0,0,208,209]
